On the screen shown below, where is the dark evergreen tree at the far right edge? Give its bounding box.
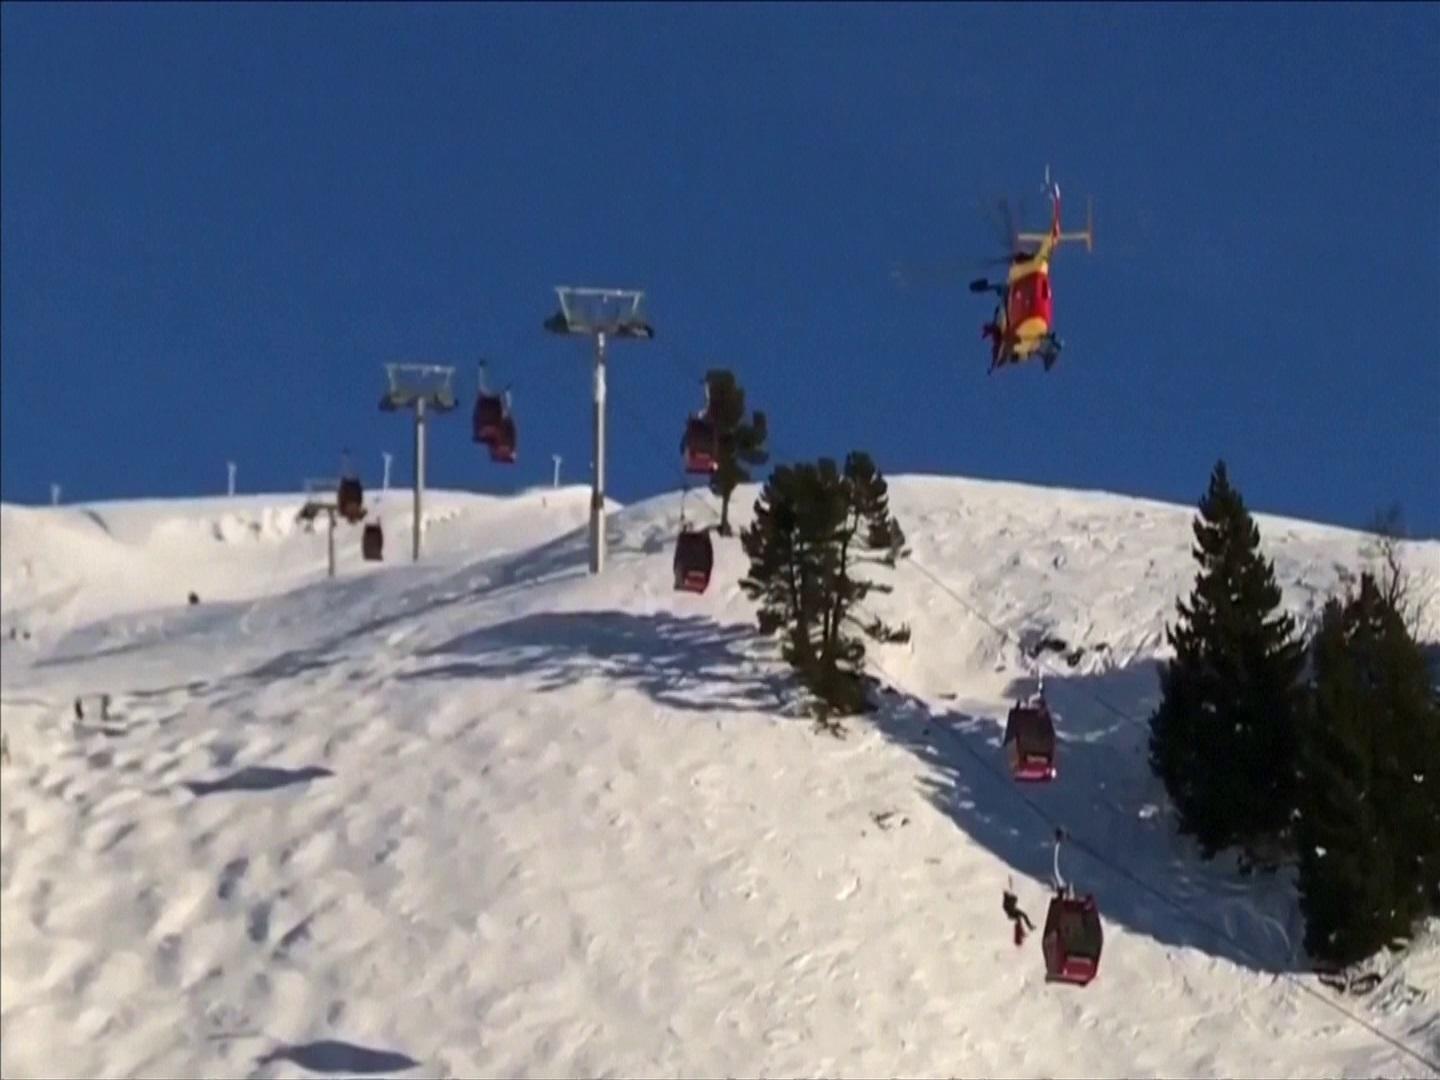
[1296,573,1440,966]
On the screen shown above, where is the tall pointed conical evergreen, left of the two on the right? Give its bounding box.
[1151,461,1305,865]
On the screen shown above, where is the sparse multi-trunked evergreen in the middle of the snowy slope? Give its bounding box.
[740,451,910,713]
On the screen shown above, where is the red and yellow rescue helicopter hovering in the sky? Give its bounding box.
[971,166,1094,372]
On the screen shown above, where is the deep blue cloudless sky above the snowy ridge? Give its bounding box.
[0,3,1440,536]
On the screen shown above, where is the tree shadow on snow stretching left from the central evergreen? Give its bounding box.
[397,611,793,711]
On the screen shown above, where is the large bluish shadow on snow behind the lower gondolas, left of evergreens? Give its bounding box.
[874,661,1308,973]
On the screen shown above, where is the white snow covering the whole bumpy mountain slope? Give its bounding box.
[0,477,1440,1077]
